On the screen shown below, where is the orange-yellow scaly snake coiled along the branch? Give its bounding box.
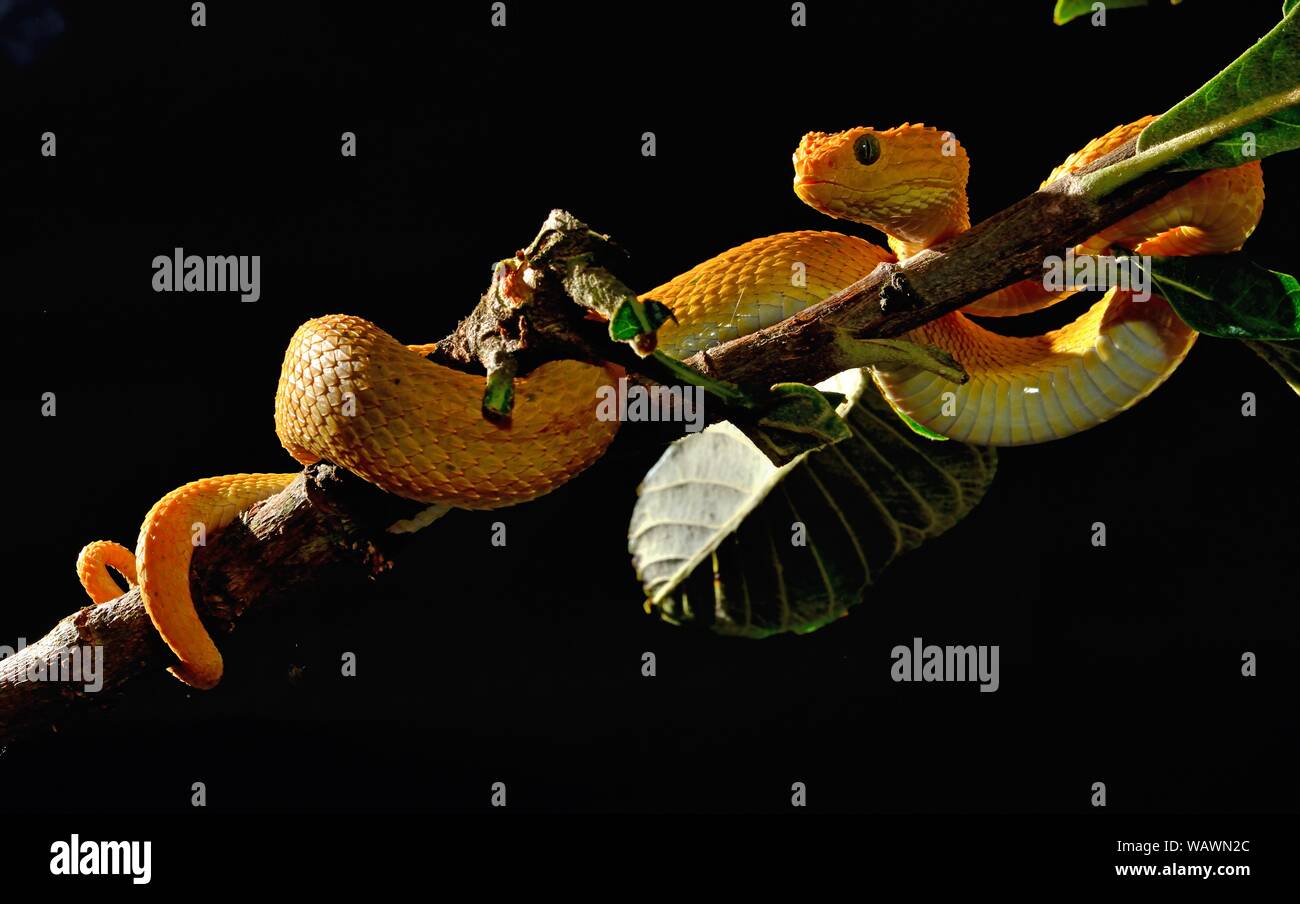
[77,116,1264,689]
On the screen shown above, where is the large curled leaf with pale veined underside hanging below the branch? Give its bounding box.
[628,371,996,637]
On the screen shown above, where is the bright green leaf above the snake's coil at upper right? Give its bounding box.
[1138,8,1300,169]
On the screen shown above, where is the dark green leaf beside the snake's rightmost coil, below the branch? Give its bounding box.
[1125,252,1300,339]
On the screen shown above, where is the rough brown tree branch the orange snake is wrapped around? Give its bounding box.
[0,134,1196,745]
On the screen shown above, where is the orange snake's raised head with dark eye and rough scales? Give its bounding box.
[794,124,970,252]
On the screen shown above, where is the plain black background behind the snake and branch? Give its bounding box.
[0,0,1300,832]
